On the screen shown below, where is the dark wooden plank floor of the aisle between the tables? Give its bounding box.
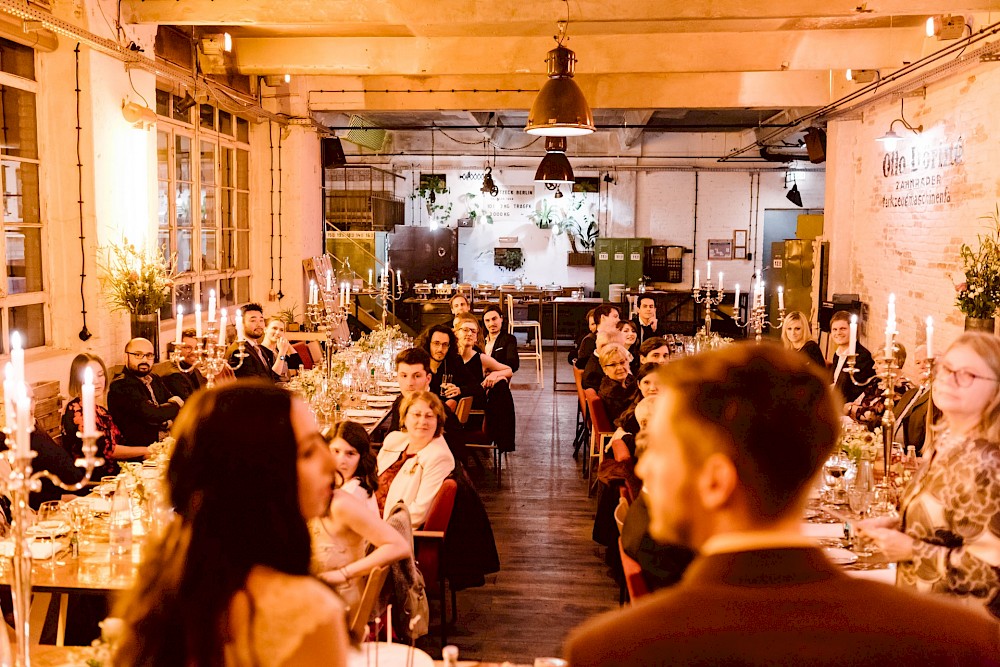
[420,380,618,664]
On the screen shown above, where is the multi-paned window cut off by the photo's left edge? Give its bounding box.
[0,38,47,352]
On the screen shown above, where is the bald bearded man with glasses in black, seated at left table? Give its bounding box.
[108,338,184,457]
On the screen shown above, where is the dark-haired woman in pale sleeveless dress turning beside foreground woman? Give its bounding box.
[309,421,411,607]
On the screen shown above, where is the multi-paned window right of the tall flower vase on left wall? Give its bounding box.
[156,90,250,319]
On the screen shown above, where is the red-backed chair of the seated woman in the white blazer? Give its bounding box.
[413,479,458,646]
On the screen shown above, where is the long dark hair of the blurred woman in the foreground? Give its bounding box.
[118,380,310,666]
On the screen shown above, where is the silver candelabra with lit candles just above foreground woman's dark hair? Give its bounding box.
[170,302,250,389]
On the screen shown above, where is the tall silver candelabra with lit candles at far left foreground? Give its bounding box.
[0,332,104,667]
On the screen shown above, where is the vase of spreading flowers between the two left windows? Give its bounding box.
[99,239,175,361]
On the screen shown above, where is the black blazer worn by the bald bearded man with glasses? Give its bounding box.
[108,368,180,447]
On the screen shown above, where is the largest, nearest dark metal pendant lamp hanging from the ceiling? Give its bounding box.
[524,0,596,137]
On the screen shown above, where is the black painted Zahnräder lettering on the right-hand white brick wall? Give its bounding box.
[879,137,965,208]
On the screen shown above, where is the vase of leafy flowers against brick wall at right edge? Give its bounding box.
[955,205,1000,333]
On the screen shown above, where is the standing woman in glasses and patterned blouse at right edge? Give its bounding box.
[861,333,1000,618]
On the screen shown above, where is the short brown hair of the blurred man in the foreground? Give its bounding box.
[660,343,840,519]
